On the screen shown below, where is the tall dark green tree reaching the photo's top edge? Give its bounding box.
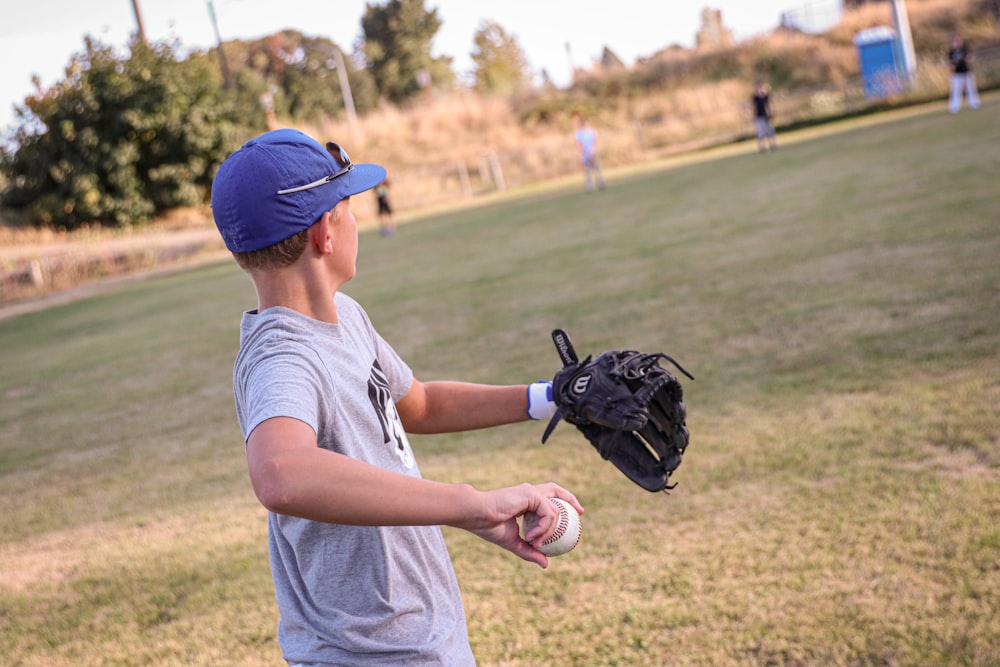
[361,0,455,104]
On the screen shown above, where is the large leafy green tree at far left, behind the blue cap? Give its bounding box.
[0,38,252,229]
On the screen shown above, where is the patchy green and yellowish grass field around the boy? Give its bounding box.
[0,96,1000,667]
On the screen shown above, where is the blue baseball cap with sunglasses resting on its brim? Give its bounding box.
[212,129,386,252]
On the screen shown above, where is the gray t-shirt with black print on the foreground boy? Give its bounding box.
[233,293,475,666]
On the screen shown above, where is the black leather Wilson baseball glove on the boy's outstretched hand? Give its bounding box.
[542,329,694,492]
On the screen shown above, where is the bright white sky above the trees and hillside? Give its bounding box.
[0,0,816,130]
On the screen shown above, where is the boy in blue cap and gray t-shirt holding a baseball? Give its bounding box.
[212,129,583,665]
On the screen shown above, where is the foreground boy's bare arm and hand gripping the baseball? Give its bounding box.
[246,417,583,567]
